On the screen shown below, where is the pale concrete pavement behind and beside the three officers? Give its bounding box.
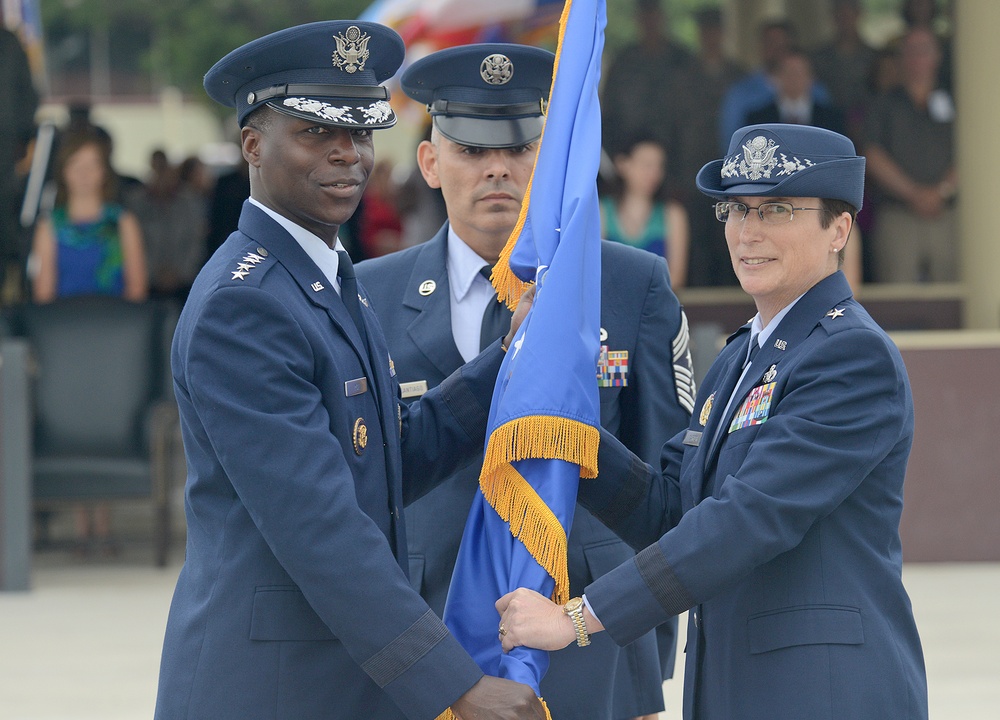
[0,547,1000,720]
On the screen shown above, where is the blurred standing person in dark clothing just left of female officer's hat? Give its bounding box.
[670,8,743,286]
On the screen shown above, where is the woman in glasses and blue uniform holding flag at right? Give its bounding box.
[498,124,927,720]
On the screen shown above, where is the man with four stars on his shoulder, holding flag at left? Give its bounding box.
[156,21,543,720]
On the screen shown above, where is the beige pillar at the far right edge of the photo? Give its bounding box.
[953,0,1000,329]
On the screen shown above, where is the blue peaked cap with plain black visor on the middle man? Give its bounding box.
[400,43,555,148]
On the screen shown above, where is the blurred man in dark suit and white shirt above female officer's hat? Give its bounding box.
[747,48,844,135]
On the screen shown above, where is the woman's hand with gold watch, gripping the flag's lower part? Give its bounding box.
[496,588,576,652]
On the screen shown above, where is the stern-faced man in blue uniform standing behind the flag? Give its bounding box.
[358,44,694,720]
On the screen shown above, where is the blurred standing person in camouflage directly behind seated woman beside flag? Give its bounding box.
[601,0,694,191]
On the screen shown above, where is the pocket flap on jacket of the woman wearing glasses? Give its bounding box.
[747,605,865,654]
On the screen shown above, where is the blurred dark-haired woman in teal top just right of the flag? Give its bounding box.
[601,135,688,290]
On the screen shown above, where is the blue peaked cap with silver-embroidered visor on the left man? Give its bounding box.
[205,20,405,129]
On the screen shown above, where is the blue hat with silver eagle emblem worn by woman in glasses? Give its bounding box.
[695,123,865,210]
